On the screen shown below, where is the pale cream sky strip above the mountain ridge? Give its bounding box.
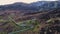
[0,0,56,5]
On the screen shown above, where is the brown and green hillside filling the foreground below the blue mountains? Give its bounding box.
[0,8,60,34]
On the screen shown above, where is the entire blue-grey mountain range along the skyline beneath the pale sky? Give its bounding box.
[0,1,60,11]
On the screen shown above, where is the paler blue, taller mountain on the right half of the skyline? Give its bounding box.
[31,1,60,10]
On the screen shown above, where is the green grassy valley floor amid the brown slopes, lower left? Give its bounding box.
[0,16,39,34]
